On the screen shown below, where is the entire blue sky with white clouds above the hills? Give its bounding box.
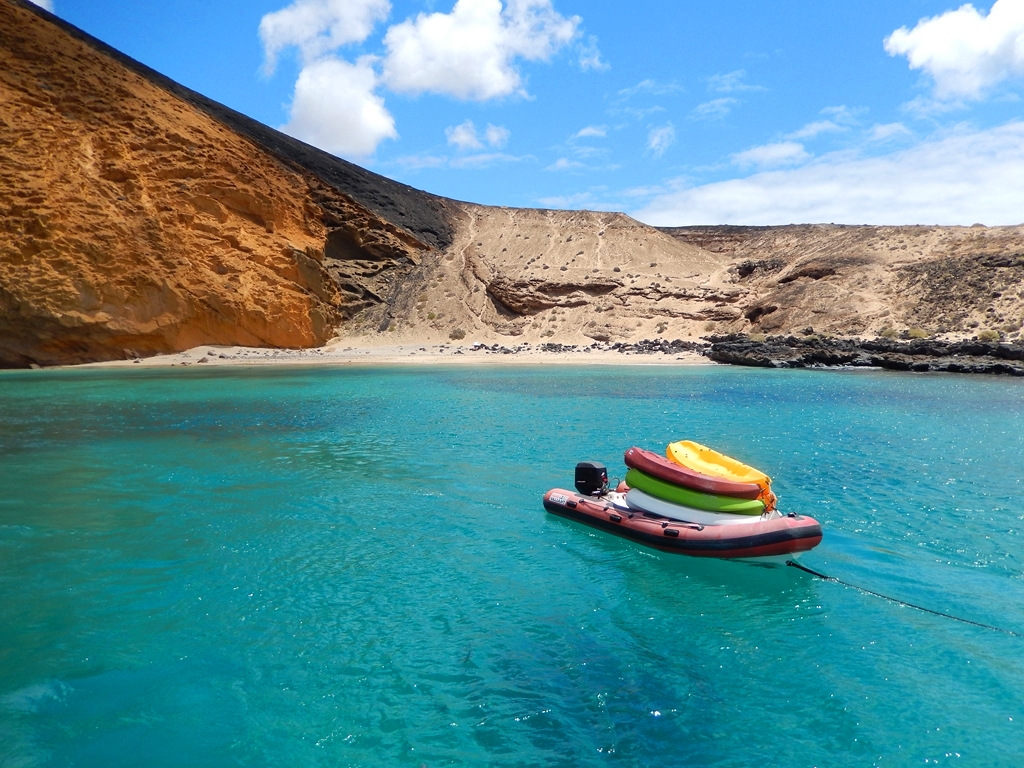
[40,0,1024,225]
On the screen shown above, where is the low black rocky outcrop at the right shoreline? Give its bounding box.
[705,334,1024,376]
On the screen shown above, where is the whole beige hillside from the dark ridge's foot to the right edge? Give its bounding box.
[343,215,1024,344]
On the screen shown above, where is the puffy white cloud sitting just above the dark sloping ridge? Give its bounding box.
[282,58,398,157]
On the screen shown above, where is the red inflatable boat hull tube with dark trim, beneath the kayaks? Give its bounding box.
[544,488,821,559]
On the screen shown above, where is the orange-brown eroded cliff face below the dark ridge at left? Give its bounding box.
[0,0,427,367]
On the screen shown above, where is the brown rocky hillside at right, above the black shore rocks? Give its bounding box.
[664,224,1024,338]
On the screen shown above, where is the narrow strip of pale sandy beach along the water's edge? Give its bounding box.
[72,339,718,368]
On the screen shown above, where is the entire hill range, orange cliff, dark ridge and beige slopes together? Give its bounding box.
[0,0,1024,367]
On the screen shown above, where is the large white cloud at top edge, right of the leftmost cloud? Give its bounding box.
[383,0,582,101]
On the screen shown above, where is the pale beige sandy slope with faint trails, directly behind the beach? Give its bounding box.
[343,204,749,343]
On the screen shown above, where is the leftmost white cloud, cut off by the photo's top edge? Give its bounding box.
[259,0,391,75]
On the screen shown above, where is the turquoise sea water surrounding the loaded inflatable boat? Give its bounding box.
[0,367,1024,767]
